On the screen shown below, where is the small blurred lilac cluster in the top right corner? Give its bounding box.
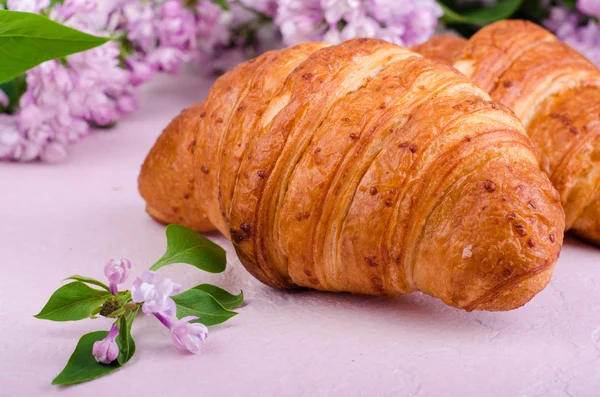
[544,0,600,66]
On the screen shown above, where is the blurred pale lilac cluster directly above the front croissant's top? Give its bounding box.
[275,0,443,47]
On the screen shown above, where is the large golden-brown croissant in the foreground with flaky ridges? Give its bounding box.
[139,39,564,310]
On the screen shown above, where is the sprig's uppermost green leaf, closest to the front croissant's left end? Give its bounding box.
[150,225,227,273]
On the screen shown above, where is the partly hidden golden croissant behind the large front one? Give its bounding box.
[413,20,600,244]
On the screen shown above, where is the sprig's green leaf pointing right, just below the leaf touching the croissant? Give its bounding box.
[173,289,237,326]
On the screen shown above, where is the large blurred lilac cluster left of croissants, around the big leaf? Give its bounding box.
[0,0,234,162]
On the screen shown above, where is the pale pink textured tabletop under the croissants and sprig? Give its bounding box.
[0,72,600,397]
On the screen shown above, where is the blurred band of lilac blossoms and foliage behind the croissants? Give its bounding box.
[0,0,600,162]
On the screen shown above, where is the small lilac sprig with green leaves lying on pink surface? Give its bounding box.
[35,225,244,385]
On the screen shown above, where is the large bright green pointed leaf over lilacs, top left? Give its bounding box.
[0,10,110,83]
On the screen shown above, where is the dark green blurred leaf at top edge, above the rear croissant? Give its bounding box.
[438,0,523,26]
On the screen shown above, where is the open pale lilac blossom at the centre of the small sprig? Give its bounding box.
[131,270,181,316]
